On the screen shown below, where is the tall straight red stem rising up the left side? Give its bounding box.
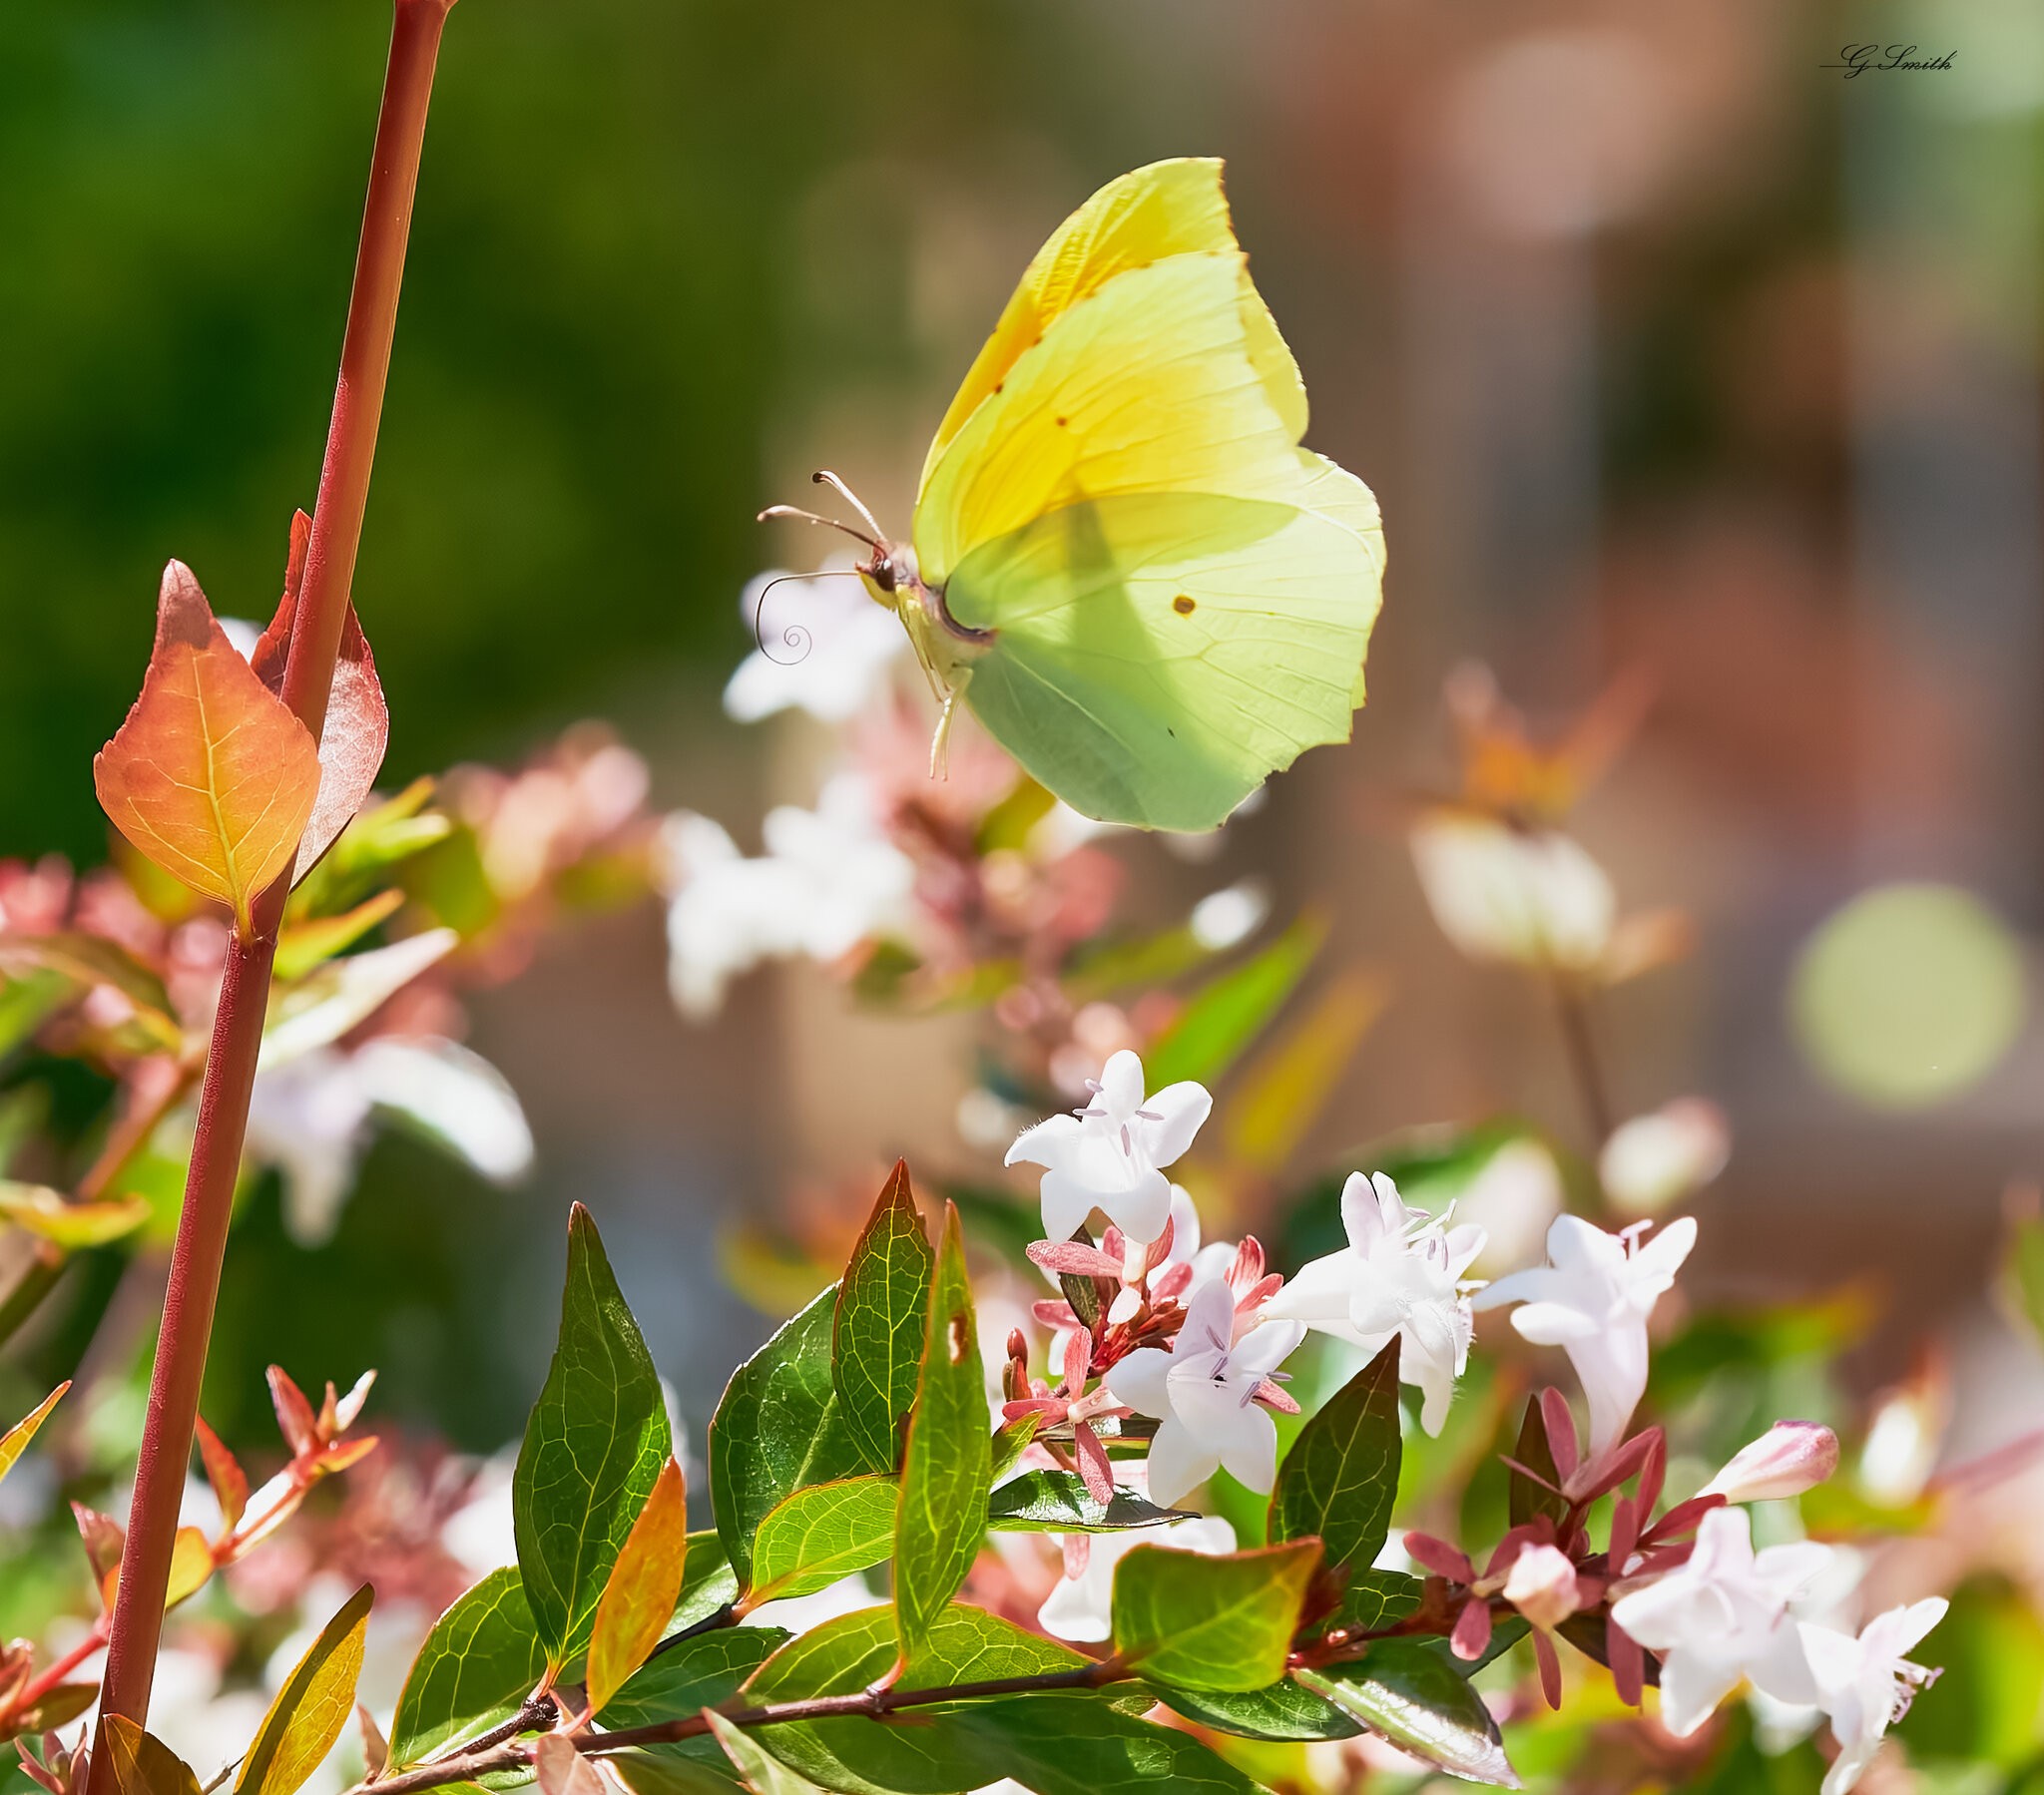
[90,0,454,1749]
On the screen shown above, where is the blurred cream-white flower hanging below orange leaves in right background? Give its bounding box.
[1410,809,1617,971]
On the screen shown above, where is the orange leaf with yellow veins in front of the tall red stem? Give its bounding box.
[92,560,318,930]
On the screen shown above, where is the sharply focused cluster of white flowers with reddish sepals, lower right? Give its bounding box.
[1002,1053,1946,1795]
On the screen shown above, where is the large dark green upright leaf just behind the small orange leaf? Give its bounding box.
[511,1204,671,1670]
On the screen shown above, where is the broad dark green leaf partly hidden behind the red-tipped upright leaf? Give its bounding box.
[710,1284,864,1588]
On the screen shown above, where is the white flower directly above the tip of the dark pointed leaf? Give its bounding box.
[1264,1171,1484,1433]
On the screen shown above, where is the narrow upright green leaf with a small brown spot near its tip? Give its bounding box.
[895,1204,991,1652]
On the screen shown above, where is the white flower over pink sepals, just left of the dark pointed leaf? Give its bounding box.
[1106,1282,1306,1505]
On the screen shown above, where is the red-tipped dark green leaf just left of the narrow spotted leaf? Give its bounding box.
[829,1159,936,1470]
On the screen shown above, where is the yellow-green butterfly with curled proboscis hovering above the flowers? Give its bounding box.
[761,158,1383,830]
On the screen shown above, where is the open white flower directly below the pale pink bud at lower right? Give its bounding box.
[1611,1509,1829,1738]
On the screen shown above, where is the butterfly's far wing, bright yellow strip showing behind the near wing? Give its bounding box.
[922,156,1306,485]
